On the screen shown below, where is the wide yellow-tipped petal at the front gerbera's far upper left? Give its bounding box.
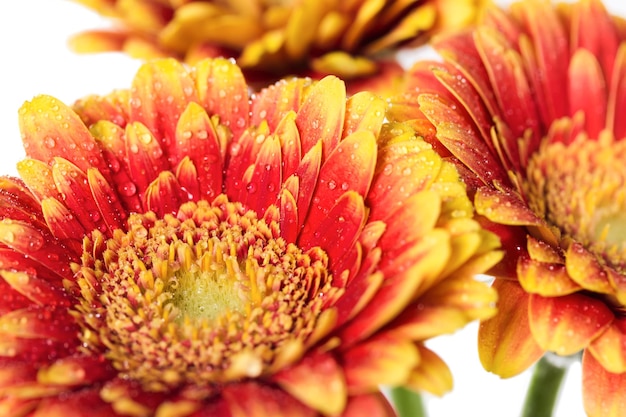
[19,96,109,180]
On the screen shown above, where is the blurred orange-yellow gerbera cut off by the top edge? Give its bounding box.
[71,0,485,88]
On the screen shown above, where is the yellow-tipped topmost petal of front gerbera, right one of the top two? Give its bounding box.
[194,58,250,140]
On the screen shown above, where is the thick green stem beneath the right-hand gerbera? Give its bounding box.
[522,353,573,417]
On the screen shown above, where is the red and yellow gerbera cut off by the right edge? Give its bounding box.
[390,0,626,416]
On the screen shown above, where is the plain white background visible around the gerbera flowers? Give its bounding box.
[0,0,626,417]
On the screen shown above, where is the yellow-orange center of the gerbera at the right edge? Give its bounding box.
[528,131,626,274]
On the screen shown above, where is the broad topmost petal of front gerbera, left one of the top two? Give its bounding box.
[130,59,196,151]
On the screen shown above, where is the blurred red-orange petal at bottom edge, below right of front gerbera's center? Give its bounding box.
[272,354,348,415]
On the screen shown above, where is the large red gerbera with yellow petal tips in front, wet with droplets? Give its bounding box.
[0,59,501,416]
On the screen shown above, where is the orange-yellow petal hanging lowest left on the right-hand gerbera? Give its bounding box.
[478,278,544,378]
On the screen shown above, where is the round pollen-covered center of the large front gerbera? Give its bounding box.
[74,195,339,391]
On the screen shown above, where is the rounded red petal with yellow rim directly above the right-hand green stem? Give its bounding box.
[528,293,614,356]
